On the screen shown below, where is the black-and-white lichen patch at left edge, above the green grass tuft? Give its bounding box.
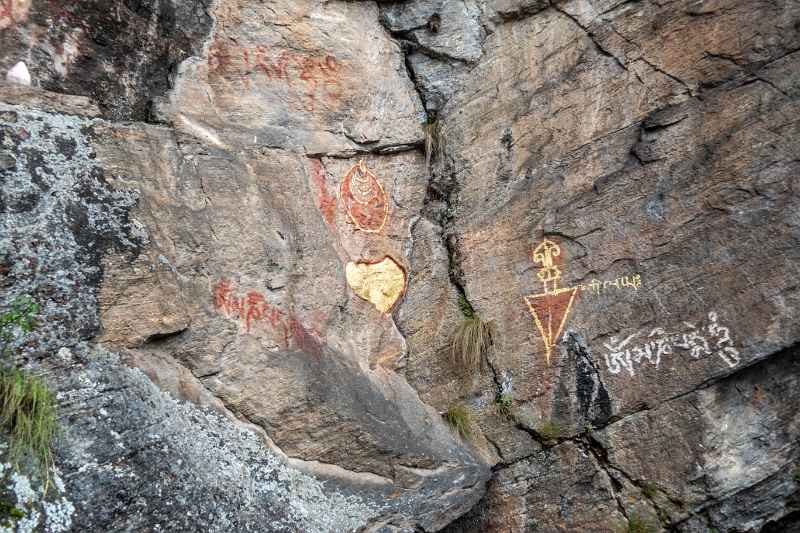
[0,92,147,350]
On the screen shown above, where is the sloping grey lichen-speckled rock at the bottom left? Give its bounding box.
[51,351,389,532]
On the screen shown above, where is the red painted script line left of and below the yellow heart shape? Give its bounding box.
[213,279,322,356]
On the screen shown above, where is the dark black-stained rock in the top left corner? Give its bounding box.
[0,0,212,120]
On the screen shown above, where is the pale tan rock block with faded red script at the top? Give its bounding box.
[159,1,424,155]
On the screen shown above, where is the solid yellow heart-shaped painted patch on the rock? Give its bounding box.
[345,256,406,314]
